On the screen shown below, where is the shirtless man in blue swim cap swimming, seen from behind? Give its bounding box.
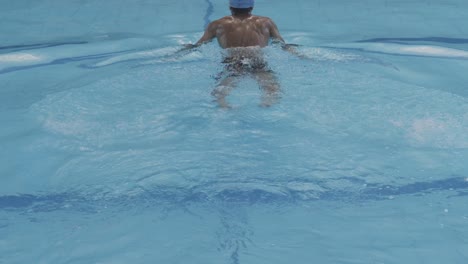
[186,0,294,108]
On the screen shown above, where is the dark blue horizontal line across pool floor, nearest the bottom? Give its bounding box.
[0,176,468,210]
